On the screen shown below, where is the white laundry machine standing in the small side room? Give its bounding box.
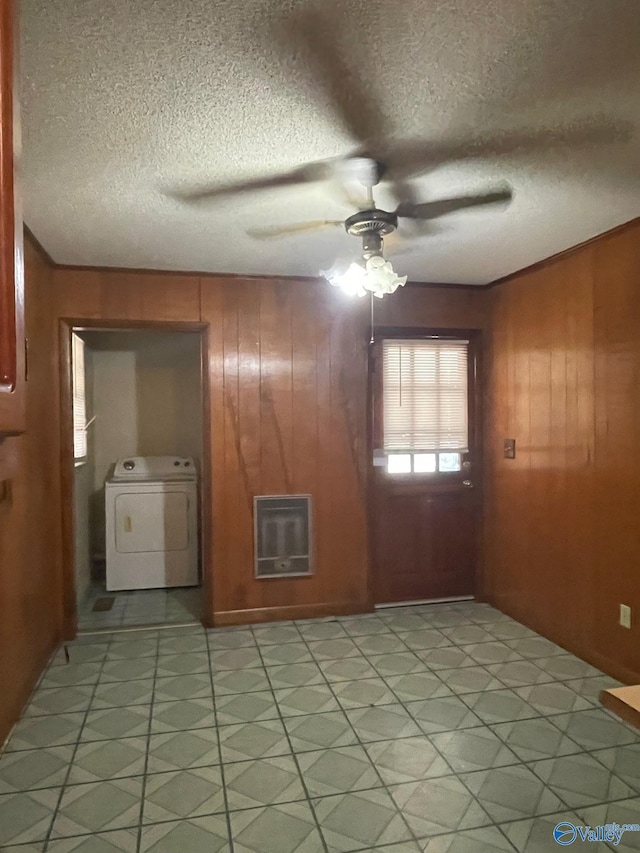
[105,456,198,591]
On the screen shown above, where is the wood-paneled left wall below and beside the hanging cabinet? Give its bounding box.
[0,236,62,744]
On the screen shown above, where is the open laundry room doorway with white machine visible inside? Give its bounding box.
[61,320,210,636]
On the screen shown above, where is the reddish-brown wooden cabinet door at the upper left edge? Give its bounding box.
[0,0,25,436]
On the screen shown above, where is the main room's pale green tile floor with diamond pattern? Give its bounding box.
[0,602,640,853]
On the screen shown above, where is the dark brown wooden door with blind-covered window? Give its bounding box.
[371,331,482,604]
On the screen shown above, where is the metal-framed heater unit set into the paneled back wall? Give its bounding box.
[253,495,312,578]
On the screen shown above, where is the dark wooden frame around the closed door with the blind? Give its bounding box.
[366,326,486,607]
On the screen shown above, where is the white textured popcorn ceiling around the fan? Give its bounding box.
[21,0,640,284]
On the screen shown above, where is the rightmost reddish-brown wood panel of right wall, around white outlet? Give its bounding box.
[593,228,640,672]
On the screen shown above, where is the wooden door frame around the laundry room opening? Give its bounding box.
[58,317,214,640]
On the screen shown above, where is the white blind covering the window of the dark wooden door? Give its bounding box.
[382,339,469,453]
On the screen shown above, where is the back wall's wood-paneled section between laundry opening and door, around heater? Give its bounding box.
[202,279,369,621]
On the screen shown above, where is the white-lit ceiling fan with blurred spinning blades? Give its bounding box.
[173,3,632,295]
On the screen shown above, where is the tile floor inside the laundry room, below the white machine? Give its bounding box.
[78,581,202,631]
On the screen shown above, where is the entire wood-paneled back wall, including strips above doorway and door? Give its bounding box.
[54,268,486,624]
